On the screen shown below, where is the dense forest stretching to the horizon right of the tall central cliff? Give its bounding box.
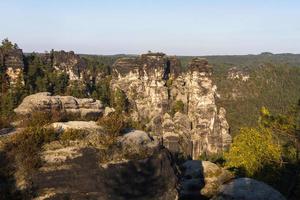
[179,53,300,135]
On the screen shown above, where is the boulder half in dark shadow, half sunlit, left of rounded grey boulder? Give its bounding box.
[180,160,233,199]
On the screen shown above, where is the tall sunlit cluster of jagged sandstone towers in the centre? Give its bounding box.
[111,53,231,159]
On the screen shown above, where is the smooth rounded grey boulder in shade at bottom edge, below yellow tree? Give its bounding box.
[212,178,285,200]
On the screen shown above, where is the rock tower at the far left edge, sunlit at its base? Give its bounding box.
[0,49,24,86]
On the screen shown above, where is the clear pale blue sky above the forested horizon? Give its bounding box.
[0,0,300,55]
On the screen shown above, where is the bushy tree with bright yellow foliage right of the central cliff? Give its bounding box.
[224,128,282,176]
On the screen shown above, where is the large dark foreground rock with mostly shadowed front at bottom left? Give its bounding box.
[33,131,178,200]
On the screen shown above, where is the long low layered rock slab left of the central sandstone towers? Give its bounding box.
[14,92,104,119]
